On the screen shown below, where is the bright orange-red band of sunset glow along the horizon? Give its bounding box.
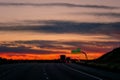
[0,53,103,60]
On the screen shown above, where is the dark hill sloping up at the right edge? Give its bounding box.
[96,47,120,63]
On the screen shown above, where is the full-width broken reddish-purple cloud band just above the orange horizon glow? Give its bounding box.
[0,40,120,54]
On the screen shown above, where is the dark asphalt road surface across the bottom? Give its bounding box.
[0,63,120,80]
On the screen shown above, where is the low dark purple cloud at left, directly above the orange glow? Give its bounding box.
[0,46,65,54]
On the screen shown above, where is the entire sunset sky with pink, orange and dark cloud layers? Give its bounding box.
[0,0,120,59]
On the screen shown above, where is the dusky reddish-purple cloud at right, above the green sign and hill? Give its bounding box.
[64,41,120,53]
